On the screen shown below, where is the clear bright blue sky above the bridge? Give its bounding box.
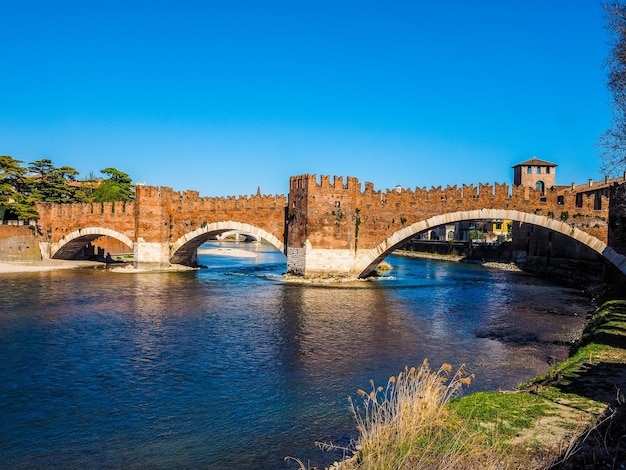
[0,0,611,196]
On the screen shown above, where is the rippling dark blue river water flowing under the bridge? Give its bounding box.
[0,244,591,469]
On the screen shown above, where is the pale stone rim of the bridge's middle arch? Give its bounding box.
[170,220,285,266]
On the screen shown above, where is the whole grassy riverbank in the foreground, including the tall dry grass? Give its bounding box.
[322,301,626,470]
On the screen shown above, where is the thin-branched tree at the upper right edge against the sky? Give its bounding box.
[599,2,626,175]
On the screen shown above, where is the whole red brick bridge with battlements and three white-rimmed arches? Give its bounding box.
[37,175,626,277]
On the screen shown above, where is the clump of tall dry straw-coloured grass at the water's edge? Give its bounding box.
[335,360,498,470]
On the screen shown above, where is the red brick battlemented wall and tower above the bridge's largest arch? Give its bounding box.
[289,175,608,253]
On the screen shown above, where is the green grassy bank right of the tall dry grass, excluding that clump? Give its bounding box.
[452,300,626,469]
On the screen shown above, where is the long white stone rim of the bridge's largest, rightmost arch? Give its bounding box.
[357,209,626,278]
